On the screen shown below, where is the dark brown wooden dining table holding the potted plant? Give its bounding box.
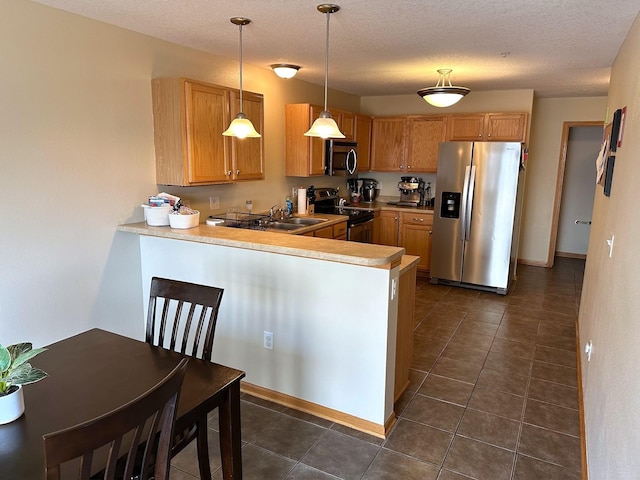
[0,329,245,480]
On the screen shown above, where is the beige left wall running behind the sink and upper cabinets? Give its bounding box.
[0,0,359,344]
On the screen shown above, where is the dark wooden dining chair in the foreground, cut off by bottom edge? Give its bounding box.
[43,358,189,480]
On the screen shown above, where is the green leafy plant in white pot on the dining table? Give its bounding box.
[0,343,47,425]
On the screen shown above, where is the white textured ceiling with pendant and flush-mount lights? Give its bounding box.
[31,0,640,97]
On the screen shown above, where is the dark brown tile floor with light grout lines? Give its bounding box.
[171,258,584,480]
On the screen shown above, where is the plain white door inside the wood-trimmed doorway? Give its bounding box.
[556,126,602,256]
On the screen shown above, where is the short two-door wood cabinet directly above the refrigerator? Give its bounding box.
[447,113,527,142]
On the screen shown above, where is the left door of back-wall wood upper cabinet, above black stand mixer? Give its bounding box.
[371,117,407,172]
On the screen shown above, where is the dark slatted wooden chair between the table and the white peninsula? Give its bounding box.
[146,277,224,480]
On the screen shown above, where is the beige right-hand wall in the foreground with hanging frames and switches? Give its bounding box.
[579,11,640,480]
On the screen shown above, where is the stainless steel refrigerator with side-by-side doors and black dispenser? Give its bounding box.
[430,142,525,295]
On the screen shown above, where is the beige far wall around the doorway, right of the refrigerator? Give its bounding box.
[518,97,607,265]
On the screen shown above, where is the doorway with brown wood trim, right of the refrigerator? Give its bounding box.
[548,122,604,267]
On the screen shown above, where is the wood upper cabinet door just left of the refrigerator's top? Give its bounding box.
[404,115,447,173]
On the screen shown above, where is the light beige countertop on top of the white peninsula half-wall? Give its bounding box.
[118,214,404,268]
